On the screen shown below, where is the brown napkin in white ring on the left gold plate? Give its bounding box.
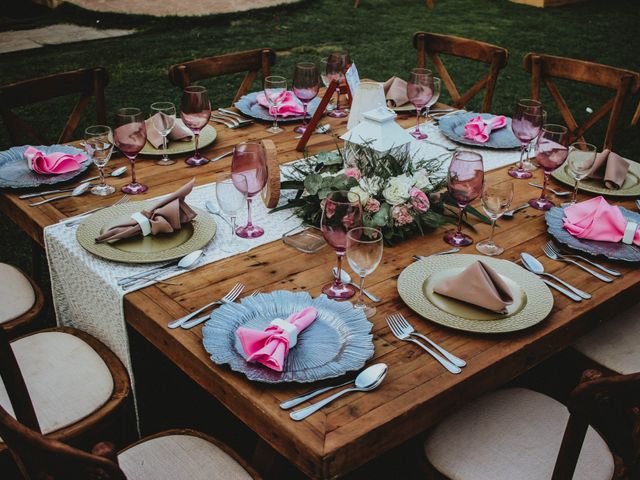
[96,178,197,243]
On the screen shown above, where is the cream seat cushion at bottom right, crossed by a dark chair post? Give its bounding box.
[425,388,614,480]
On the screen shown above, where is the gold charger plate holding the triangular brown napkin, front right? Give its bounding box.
[398,254,553,333]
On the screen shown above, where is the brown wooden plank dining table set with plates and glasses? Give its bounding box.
[0,109,640,478]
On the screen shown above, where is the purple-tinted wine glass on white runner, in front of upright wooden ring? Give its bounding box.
[231,142,268,238]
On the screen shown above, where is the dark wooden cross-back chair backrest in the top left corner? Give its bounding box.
[0,67,109,145]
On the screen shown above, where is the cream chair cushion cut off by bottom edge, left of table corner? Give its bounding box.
[118,434,252,480]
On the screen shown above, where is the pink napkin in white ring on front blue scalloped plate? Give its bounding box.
[236,307,318,372]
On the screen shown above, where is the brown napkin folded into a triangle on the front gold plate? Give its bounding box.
[433,260,513,314]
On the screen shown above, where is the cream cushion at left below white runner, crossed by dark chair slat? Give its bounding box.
[0,332,113,434]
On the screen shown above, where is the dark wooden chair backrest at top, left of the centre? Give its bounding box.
[169,48,276,102]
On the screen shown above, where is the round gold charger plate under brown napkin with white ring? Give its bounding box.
[76,200,217,263]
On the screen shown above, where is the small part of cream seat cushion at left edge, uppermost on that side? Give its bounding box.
[0,263,36,323]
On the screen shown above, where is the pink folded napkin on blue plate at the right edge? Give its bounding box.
[564,197,640,245]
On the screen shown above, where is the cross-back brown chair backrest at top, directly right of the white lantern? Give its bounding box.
[413,32,509,112]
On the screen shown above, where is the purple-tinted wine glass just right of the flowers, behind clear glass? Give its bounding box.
[443,150,484,247]
